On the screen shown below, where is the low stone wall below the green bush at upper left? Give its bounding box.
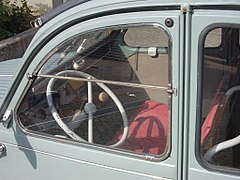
[0,28,37,62]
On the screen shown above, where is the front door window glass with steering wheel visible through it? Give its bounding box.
[18,26,171,158]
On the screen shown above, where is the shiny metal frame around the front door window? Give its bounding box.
[15,23,173,162]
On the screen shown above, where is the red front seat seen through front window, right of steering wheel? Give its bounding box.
[118,100,169,154]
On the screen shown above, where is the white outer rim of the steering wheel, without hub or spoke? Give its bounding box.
[46,70,128,147]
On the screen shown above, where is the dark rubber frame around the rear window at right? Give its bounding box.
[195,23,240,176]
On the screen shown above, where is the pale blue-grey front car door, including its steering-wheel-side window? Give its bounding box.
[0,3,181,180]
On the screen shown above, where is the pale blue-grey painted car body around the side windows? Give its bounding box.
[0,0,240,180]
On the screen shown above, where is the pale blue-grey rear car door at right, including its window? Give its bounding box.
[187,8,240,179]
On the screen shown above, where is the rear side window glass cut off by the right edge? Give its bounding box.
[200,28,240,170]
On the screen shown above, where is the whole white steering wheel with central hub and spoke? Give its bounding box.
[46,70,128,147]
